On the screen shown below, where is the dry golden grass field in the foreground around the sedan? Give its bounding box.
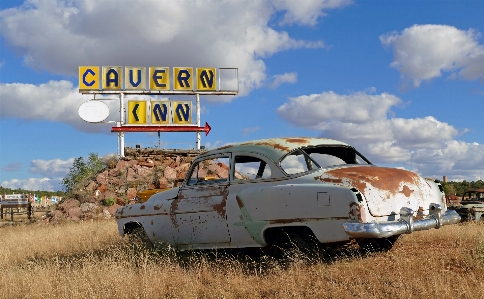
[0,221,484,298]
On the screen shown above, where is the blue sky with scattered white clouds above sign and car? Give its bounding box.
[0,0,484,190]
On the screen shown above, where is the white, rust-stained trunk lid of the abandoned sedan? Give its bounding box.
[316,165,445,216]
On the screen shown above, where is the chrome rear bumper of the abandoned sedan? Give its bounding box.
[343,203,460,238]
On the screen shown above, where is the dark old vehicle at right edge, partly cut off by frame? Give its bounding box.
[450,189,484,221]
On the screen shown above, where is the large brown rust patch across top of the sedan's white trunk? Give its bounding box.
[320,166,419,199]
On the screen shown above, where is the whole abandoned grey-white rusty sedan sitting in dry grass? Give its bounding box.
[116,138,460,250]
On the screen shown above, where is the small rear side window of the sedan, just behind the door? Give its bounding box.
[234,156,271,180]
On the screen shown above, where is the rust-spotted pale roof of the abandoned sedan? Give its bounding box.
[199,137,349,162]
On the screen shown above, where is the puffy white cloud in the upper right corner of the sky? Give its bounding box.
[380,25,484,87]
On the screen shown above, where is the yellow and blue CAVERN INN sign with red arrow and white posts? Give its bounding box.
[79,66,239,157]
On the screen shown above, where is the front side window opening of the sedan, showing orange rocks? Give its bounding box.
[188,157,229,185]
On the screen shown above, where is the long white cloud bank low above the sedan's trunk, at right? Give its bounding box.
[277,90,484,180]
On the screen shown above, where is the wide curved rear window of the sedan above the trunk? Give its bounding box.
[281,146,371,174]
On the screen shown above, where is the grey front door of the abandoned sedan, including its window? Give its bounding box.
[171,154,230,249]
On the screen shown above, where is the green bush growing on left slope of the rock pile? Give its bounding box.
[62,153,106,192]
